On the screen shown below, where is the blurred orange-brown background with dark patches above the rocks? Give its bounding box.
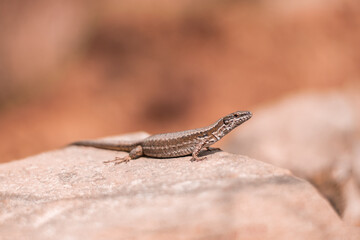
[0,0,360,162]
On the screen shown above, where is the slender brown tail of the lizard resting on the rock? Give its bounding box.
[69,140,141,152]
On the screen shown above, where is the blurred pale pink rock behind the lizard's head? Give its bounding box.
[224,91,360,226]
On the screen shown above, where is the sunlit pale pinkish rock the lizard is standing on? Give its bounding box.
[0,132,359,239]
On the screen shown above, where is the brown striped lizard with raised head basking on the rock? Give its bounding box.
[70,111,252,164]
